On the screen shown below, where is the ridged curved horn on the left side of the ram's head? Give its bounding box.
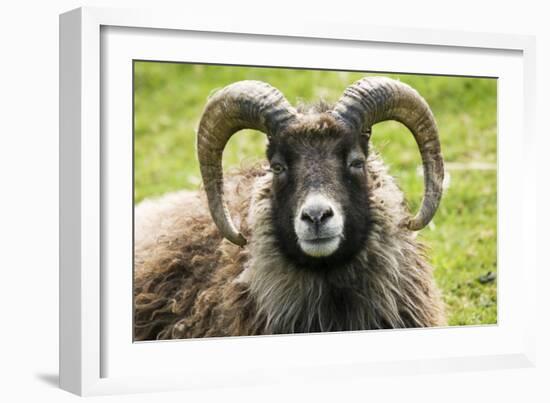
[197,81,296,246]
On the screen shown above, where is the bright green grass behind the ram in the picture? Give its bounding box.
[134,62,497,325]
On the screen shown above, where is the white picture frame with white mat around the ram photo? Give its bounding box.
[60,8,536,395]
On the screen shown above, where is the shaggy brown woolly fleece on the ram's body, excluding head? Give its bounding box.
[134,152,445,340]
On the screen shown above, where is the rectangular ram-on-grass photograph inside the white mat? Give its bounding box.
[132,60,498,342]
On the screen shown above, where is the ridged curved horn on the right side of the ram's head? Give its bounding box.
[332,77,444,231]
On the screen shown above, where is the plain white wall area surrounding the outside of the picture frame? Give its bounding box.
[0,0,550,402]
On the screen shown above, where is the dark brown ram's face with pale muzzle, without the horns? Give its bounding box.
[267,117,369,269]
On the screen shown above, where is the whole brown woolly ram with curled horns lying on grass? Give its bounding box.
[134,77,445,340]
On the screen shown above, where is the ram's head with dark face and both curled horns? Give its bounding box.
[197,77,443,264]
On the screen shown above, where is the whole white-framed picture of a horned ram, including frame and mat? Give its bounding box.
[60,8,535,395]
